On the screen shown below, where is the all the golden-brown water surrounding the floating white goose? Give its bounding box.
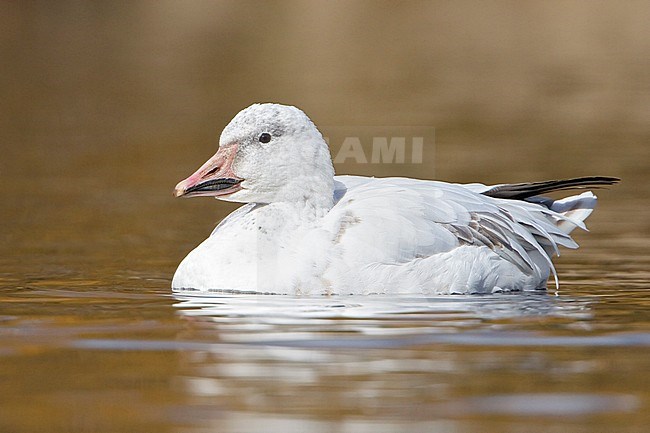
[0,2,650,433]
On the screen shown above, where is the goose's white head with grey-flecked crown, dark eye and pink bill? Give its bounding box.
[174,104,334,207]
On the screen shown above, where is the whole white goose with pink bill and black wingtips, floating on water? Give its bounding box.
[172,104,618,294]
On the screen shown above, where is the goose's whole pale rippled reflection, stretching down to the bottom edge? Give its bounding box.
[159,293,650,432]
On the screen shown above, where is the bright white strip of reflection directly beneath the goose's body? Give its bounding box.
[174,291,589,319]
